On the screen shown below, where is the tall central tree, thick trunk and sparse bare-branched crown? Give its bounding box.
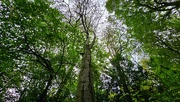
[56,0,101,102]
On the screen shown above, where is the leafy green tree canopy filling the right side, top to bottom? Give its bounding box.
[106,0,180,101]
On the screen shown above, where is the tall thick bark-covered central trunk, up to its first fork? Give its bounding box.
[76,44,94,102]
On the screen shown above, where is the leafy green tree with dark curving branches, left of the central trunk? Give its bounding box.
[0,0,81,102]
